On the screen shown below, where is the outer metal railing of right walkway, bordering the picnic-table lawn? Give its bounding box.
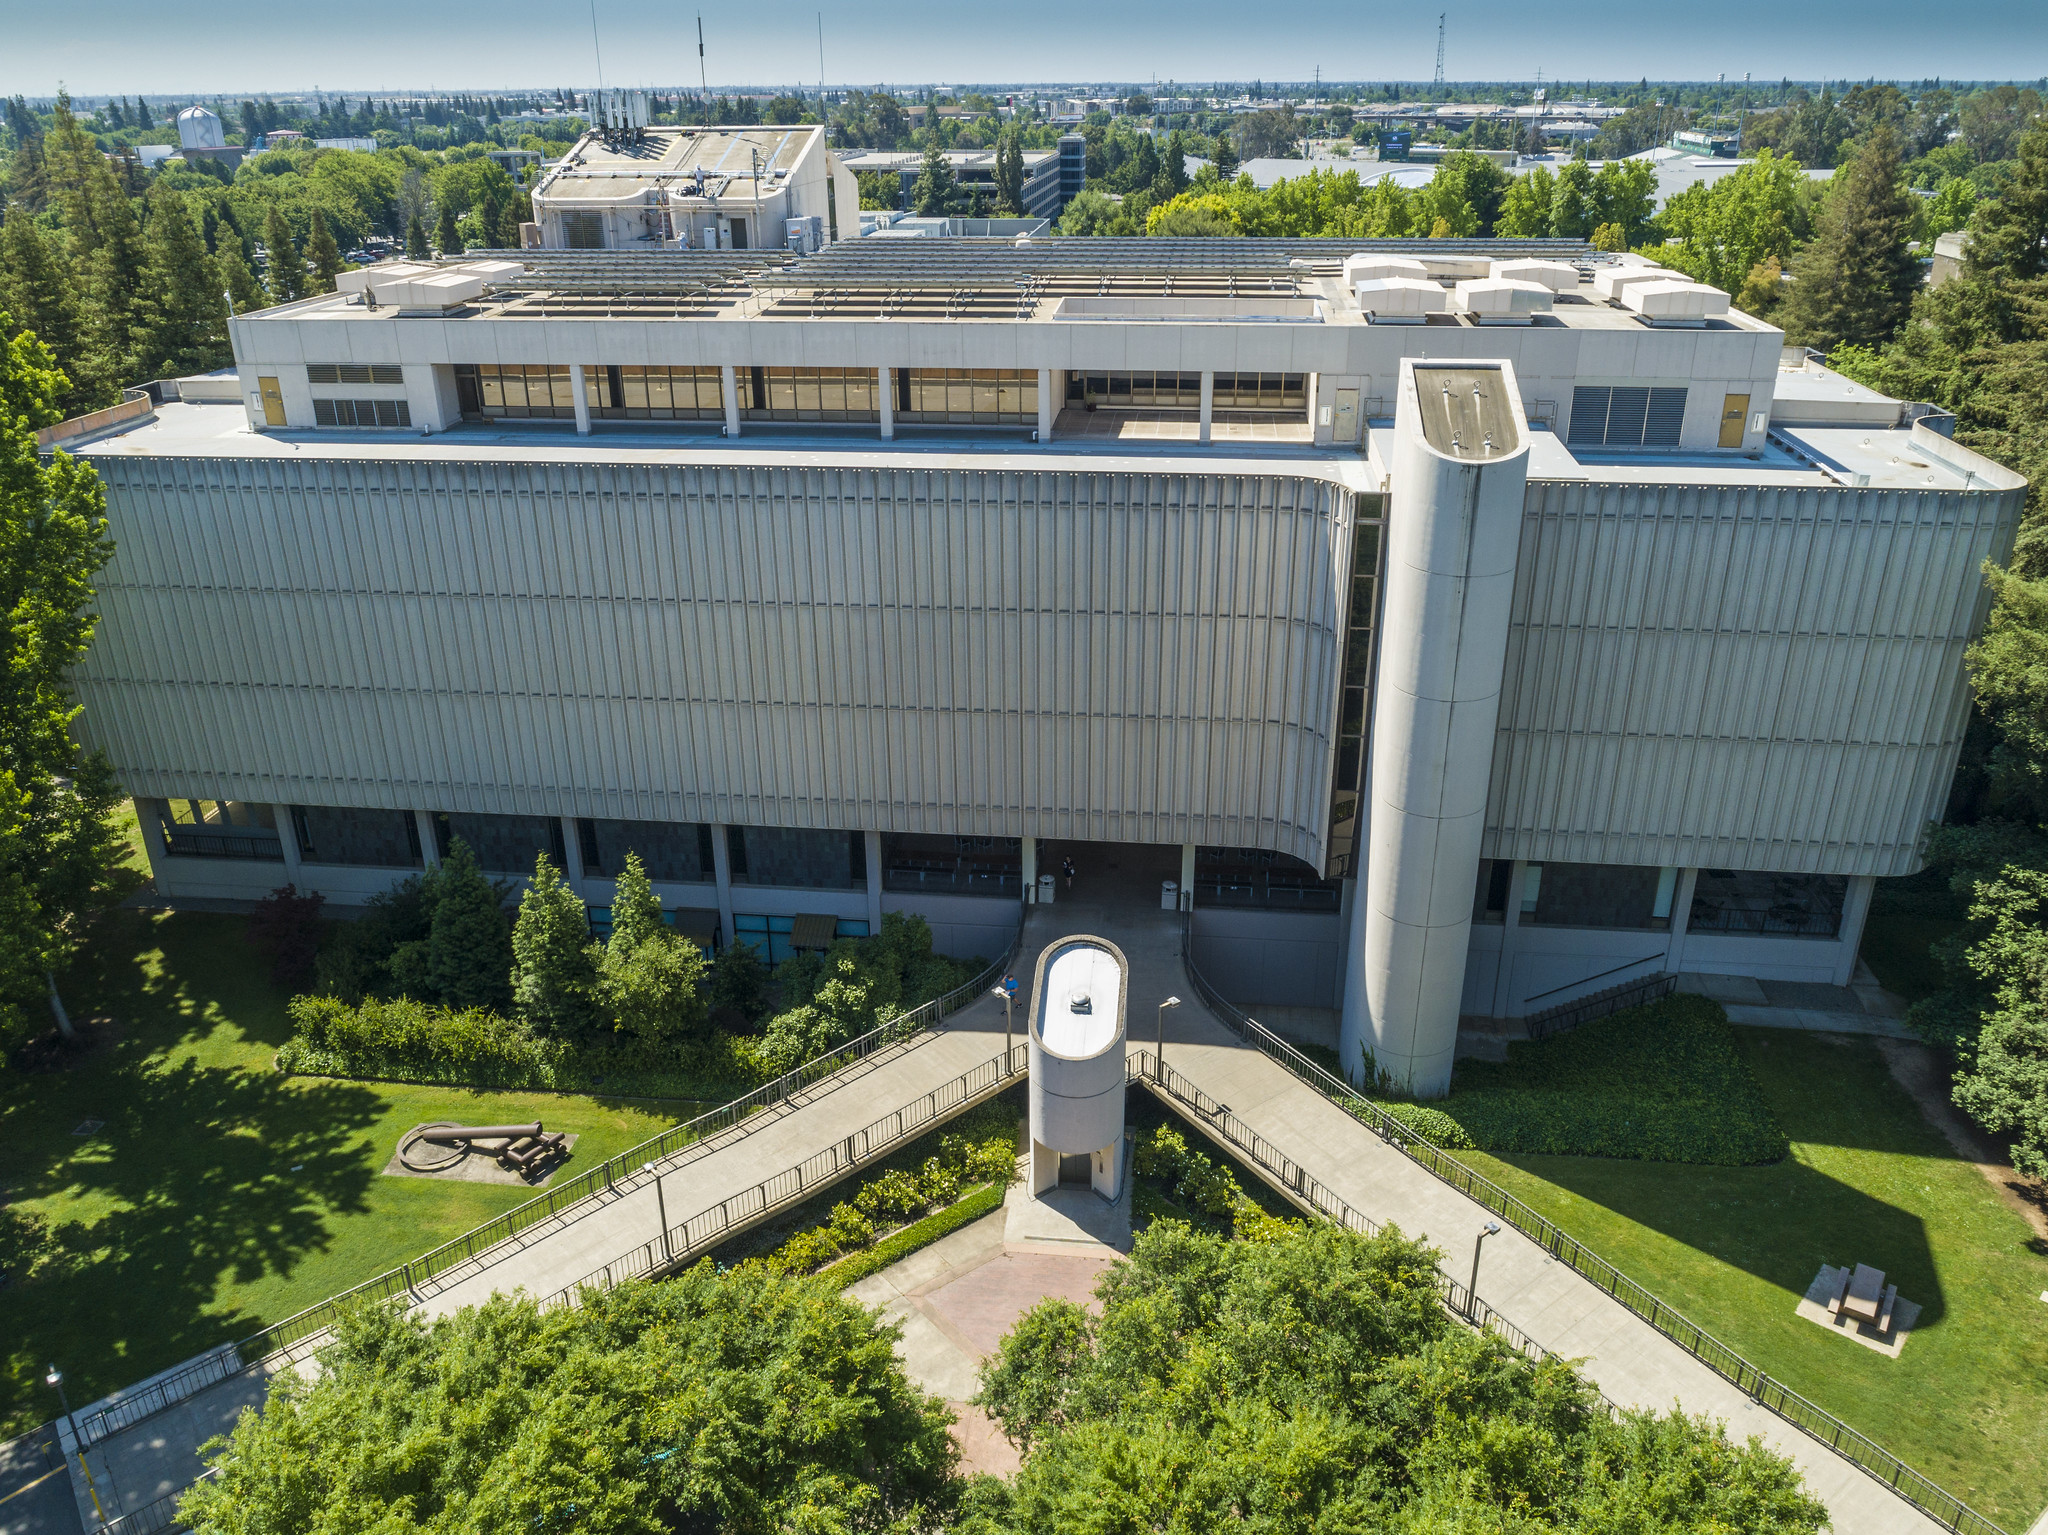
[1180,915,2007,1535]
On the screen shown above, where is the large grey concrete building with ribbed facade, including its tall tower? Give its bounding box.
[56,222,2023,1093]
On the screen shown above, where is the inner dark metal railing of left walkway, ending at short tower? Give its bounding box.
[541,1044,1030,1308]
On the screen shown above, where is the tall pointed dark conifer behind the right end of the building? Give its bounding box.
[1784,127,1921,348]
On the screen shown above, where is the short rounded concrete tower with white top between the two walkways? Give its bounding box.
[1028,933,1128,1199]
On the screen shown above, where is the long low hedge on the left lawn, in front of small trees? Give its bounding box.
[276,997,768,1103]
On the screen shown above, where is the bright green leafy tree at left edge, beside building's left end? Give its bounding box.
[0,321,125,1058]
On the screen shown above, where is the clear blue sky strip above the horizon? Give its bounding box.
[0,0,2048,96]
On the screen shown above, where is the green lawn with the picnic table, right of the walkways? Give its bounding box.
[1460,1027,2048,1535]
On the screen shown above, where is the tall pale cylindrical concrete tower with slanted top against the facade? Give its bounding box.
[1341,358,1528,1097]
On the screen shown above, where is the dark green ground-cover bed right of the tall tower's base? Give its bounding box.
[1417,993,1790,1167]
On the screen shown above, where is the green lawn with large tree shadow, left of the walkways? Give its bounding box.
[0,911,694,1437]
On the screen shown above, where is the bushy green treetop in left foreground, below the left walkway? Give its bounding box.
[180,1263,958,1535]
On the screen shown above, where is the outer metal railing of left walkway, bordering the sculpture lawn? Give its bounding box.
[78,939,1016,1447]
